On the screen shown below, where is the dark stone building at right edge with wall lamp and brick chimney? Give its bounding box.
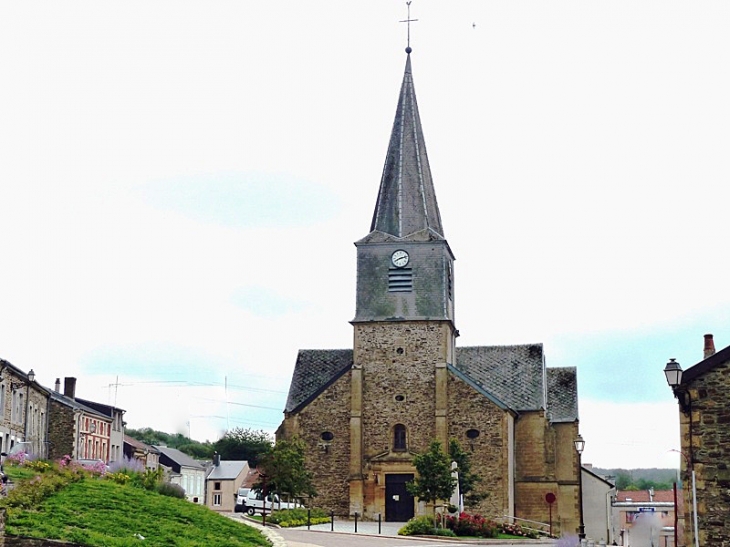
[665,334,730,546]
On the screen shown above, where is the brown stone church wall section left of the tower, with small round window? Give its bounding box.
[284,374,350,515]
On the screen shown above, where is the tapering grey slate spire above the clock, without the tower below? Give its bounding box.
[370,50,444,239]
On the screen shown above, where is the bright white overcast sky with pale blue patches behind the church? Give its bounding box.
[0,0,730,467]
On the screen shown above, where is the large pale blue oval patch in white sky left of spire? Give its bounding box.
[138,172,338,229]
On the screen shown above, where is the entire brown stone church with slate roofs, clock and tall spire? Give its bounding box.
[277,48,579,533]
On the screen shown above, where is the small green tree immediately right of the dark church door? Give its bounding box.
[406,441,456,523]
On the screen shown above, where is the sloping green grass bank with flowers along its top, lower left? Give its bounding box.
[0,467,270,547]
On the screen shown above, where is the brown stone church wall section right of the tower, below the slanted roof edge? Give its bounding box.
[449,376,512,518]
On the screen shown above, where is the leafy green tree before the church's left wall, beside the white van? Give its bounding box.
[258,437,317,506]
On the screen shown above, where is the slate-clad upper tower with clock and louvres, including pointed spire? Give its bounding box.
[353,47,454,325]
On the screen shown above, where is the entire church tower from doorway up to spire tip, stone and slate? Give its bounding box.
[349,47,457,520]
